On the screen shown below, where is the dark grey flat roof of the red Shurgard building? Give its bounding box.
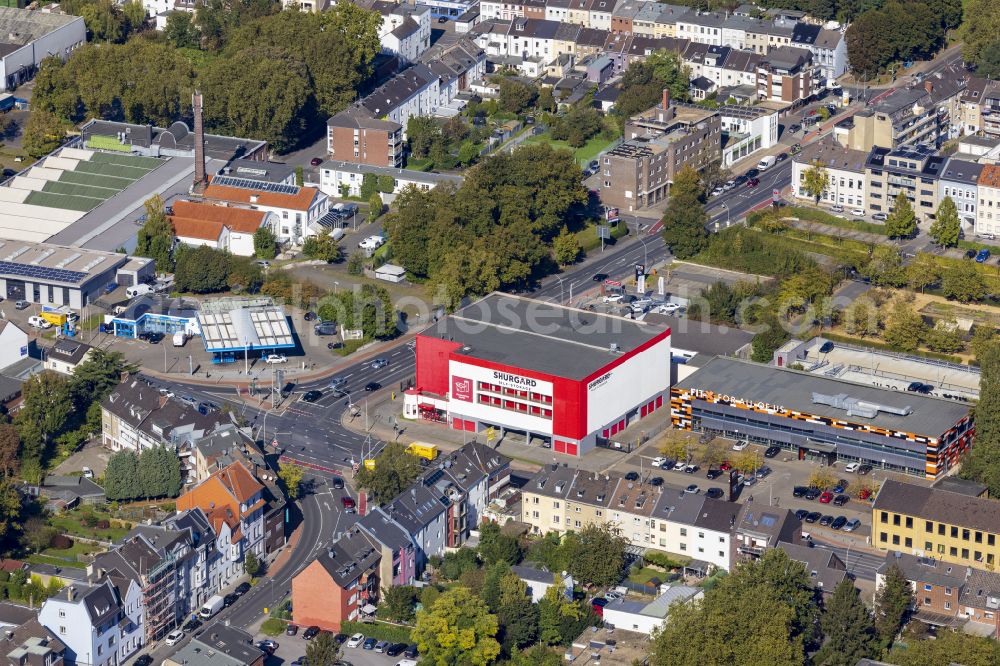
[421,293,668,379]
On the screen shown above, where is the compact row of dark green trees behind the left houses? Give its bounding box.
[104,446,181,502]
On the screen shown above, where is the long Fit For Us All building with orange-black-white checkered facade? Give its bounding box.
[670,357,974,479]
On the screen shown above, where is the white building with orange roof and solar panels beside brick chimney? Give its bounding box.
[204,176,330,245]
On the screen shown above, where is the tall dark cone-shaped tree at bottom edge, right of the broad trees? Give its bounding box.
[813,580,878,666]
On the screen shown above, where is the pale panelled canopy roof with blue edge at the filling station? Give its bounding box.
[198,298,295,352]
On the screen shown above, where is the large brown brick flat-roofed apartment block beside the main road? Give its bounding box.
[599,92,722,212]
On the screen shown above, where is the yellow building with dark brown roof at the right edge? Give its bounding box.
[872,479,1000,568]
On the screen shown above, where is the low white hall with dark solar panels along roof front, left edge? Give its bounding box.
[0,240,154,310]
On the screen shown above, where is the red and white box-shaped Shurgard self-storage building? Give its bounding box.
[404,293,670,456]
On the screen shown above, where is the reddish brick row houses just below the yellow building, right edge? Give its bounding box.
[875,550,1000,636]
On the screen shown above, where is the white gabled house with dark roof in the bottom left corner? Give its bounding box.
[38,578,127,666]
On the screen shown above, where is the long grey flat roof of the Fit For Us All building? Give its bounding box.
[676,357,969,438]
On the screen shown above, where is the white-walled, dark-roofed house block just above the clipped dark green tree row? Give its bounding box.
[101,377,221,452]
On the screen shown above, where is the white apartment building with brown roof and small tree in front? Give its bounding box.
[792,137,868,208]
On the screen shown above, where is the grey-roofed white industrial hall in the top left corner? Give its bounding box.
[0,7,87,92]
